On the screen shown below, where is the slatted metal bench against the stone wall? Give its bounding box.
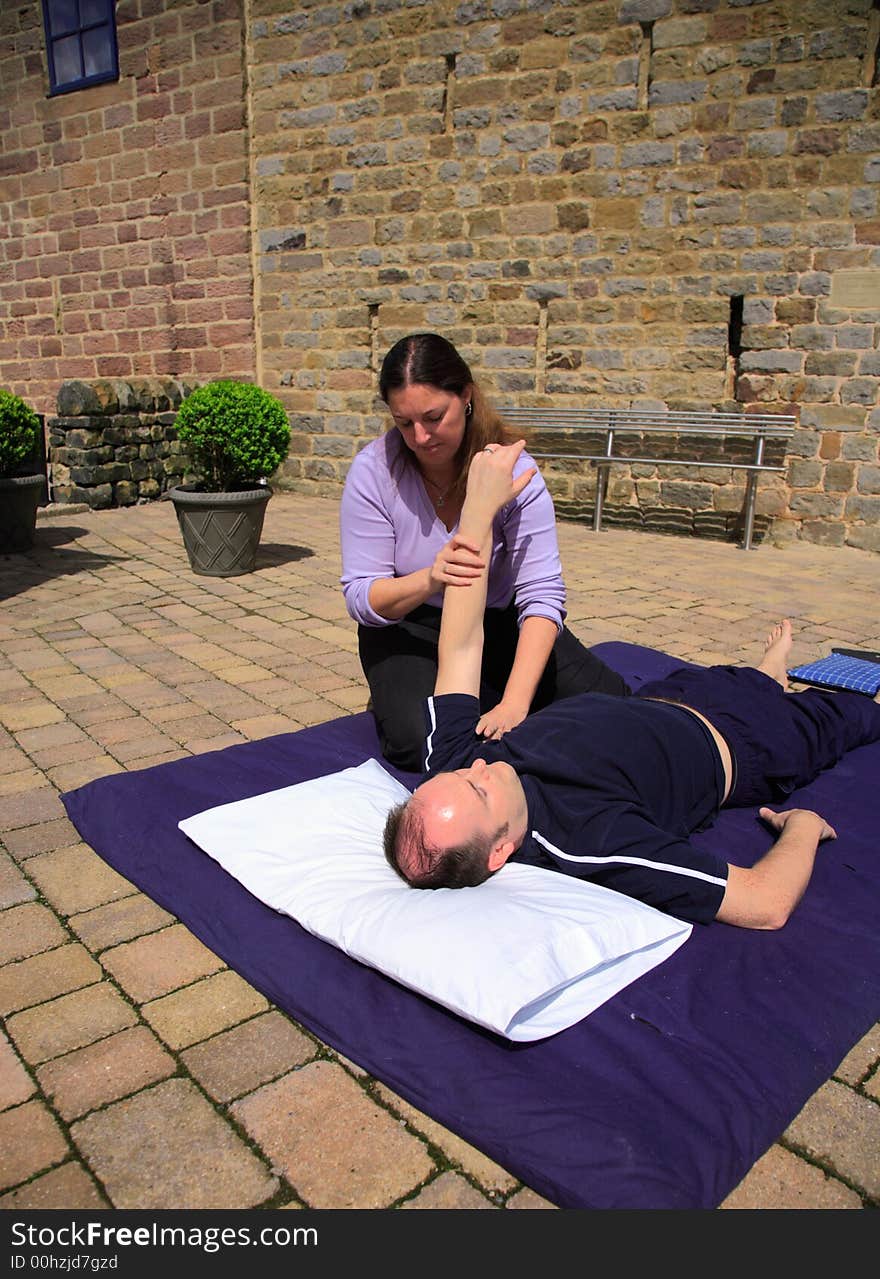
[498,405,797,550]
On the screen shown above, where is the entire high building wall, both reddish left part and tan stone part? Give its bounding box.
[0,0,880,550]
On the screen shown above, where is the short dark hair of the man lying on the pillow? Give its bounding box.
[384,799,508,888]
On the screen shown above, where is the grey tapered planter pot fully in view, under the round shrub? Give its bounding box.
[168,485,272,577]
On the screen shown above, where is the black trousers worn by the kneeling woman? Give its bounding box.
[358,604,629,773]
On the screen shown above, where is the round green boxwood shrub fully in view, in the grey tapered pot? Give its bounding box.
[175,381,290,492]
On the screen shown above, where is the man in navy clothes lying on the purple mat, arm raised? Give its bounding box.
[385,440,880,929]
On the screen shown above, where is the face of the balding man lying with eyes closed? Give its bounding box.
[414,760,528,859]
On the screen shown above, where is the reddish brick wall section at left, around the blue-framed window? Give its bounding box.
[0,0,256,413]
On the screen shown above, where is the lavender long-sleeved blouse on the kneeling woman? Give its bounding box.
[340,430,565,628]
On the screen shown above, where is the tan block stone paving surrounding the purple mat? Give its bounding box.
[0,494,880,1210]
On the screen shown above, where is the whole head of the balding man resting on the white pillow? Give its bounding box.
[385,760,528,888]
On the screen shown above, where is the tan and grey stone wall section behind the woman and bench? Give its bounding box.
[248,0,880,550]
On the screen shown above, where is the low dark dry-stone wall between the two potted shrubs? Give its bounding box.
[47,379,192,510]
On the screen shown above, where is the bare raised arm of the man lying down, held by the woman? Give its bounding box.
[434,440,536,697]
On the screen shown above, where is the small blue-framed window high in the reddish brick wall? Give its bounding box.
[42,0,119,93]
